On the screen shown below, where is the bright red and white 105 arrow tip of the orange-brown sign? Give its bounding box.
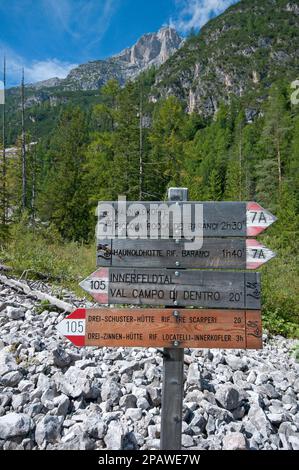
[57,308,86,346]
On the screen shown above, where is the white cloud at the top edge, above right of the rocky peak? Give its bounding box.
[171,0,238,33]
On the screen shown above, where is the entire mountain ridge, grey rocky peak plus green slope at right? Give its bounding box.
[0,0,299,145]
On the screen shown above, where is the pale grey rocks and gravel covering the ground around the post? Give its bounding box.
[0,278,299,450]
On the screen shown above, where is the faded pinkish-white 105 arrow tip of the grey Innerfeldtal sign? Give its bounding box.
[79,268,109,304]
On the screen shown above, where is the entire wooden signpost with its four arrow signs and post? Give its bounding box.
[58,188,276,450]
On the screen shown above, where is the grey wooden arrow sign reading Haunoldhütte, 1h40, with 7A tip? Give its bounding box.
[97,238,275,269]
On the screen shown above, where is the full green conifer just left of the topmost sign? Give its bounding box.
[39,108,90,240]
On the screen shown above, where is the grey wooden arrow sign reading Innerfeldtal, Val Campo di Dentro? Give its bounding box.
[80,268,261,310]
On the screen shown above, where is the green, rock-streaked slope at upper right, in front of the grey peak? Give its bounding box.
[152,0,299,117]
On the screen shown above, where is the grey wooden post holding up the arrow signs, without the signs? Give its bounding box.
[160,188,188,450]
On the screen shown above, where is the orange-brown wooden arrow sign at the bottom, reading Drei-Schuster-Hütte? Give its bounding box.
[57,308,262,349]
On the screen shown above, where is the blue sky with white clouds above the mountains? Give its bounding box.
[0,0,237,86]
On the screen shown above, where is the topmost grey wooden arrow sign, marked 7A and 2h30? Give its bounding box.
[98,202,276,239]
